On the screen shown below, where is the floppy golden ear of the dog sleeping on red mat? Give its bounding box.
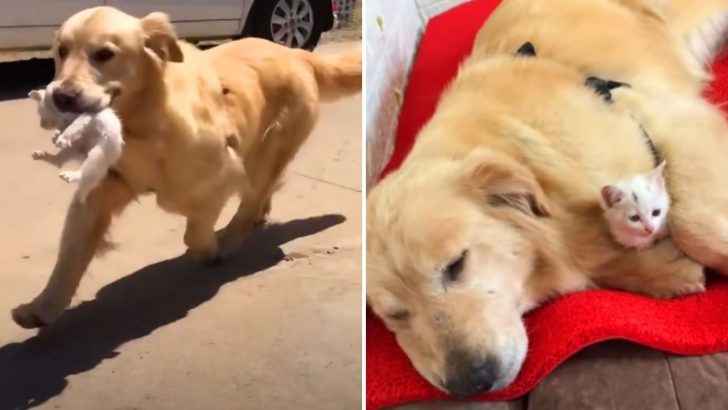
[465,153,551,217]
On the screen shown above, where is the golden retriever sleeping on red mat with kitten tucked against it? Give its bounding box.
[367,0,728,397]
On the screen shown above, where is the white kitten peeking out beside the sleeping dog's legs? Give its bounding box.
[601,161,670,249]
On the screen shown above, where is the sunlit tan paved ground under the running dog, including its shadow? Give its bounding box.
[0,44,362,410]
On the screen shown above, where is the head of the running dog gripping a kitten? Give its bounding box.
[49,7,182,113]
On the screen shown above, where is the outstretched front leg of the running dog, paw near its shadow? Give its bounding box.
[11,176,134,329]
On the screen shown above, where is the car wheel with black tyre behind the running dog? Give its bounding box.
[252,0,323,50]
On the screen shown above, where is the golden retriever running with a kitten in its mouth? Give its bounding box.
[12,7,361,328]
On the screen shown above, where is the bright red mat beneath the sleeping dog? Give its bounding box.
[366,0,728,409]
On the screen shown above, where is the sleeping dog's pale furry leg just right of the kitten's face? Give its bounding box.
[636,94,728,275]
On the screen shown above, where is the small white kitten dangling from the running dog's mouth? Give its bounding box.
[28,86,124,202]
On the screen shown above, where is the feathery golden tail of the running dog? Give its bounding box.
[308,43,362,101]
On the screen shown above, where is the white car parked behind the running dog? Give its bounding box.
[0,0,335,50]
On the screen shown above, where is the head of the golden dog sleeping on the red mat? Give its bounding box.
[367,151,550,398]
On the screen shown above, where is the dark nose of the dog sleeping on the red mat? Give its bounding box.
[443,353,498,399]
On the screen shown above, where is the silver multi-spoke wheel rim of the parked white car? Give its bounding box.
[270,0,313,47]
